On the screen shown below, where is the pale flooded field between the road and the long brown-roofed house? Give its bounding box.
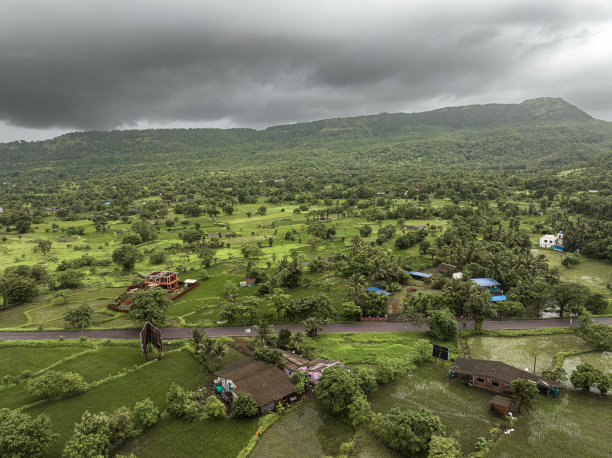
[468,334,588,373]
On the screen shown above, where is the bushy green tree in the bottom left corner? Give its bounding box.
[0,409,58,458]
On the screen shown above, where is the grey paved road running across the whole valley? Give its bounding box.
[0,317,612,340]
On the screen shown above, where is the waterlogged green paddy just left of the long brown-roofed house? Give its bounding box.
[368,364,501,456]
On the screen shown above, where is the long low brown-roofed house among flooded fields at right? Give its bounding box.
[448,358,561,397]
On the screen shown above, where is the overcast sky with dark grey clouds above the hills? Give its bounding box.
[0,0,612,141]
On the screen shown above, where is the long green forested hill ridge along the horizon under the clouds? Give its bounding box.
[0,99,612,176]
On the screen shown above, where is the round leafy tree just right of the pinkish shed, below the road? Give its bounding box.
[315,365,363,415]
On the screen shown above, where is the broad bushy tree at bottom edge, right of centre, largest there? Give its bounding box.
[370,407,444,456]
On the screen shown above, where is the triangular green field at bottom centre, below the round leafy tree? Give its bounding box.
[250,399,353,458]
